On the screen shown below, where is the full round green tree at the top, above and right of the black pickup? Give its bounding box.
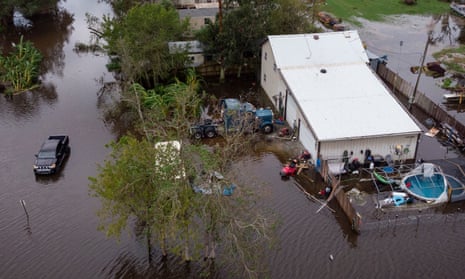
[102,4,188,84]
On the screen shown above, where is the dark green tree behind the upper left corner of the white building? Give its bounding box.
[196,0,312,81]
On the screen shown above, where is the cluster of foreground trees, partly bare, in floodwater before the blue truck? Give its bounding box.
[90,71,273,277]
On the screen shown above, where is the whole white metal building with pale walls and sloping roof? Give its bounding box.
[260,30,421,166]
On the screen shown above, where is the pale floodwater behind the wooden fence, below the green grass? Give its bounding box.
[357,14,465,122]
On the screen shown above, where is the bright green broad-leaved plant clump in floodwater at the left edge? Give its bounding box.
[0,36,42,94]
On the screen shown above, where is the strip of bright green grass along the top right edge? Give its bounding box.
[319,0,450,24]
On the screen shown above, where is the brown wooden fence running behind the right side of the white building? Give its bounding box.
[377,64,465,138]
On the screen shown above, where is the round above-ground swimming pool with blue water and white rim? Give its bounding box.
[400,163,449,203]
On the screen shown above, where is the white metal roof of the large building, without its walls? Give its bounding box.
[268,31,421,141]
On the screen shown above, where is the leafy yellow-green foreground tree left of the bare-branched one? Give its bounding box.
[89,136,192,242]
